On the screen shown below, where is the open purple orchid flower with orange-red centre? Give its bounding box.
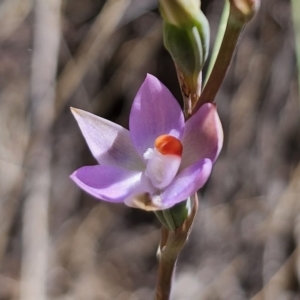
[71,75,223,210]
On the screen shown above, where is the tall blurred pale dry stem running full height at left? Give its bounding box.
[20,0,61,300]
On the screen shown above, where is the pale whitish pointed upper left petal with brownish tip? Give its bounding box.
[71,108,142,170]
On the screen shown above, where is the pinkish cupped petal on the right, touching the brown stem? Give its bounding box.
[181,103,223,169]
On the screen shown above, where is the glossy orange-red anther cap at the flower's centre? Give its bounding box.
[155,134,182,156]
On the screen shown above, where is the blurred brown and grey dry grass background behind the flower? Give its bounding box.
[0,0,300,300]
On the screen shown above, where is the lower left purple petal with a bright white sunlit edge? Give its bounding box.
[70,165,142,202]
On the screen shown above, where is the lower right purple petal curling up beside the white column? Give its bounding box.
[161,159,212,209]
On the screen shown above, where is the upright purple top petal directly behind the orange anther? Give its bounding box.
[129,74,184,157]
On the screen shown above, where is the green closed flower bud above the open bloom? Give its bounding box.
[160,0,209,110]
